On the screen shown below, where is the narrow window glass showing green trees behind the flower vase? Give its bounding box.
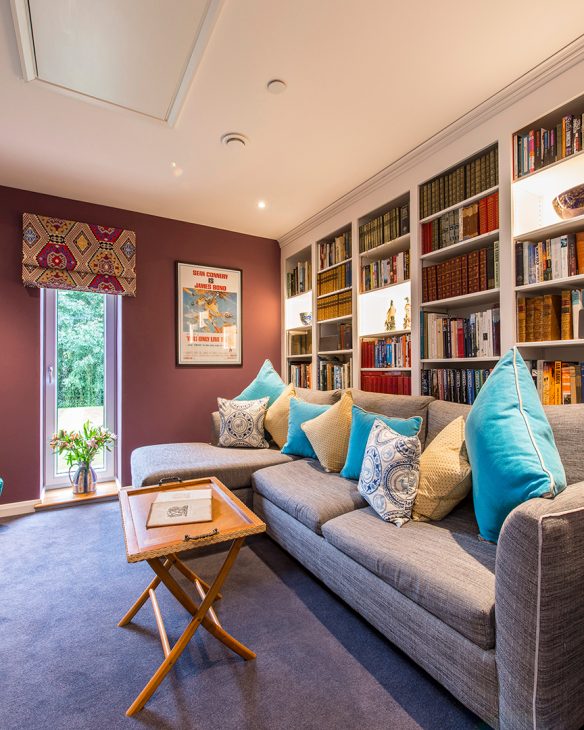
[56,290,105,474]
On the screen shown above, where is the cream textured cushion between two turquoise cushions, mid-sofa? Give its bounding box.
[301,391,353,471]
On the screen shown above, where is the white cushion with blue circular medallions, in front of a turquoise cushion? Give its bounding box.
[359,419,422,527]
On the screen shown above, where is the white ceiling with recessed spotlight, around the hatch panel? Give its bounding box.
[0,0,584,237]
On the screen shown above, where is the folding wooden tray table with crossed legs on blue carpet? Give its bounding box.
[118,477,266,715]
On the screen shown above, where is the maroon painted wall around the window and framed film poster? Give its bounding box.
[0,186,280,503]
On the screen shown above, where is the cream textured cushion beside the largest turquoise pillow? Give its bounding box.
[412,416,472,522]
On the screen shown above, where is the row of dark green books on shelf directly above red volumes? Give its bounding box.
[420,147,499,218]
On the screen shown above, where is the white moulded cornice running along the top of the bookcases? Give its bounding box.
[278,35,584,248]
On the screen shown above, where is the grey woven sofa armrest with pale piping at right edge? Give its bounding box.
[495,482,584,730]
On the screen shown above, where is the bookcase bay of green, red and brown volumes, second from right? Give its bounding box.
[419,144,501,404]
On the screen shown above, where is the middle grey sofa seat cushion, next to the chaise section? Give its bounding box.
[252,459,367,535]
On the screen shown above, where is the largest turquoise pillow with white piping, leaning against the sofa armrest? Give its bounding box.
[465,347,566,542]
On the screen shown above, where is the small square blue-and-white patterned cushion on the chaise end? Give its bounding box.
[217,398,269,449]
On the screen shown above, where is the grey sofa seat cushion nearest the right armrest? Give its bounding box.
[322,499,496,649]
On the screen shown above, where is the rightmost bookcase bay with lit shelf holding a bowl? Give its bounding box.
[511,96,584,405]
